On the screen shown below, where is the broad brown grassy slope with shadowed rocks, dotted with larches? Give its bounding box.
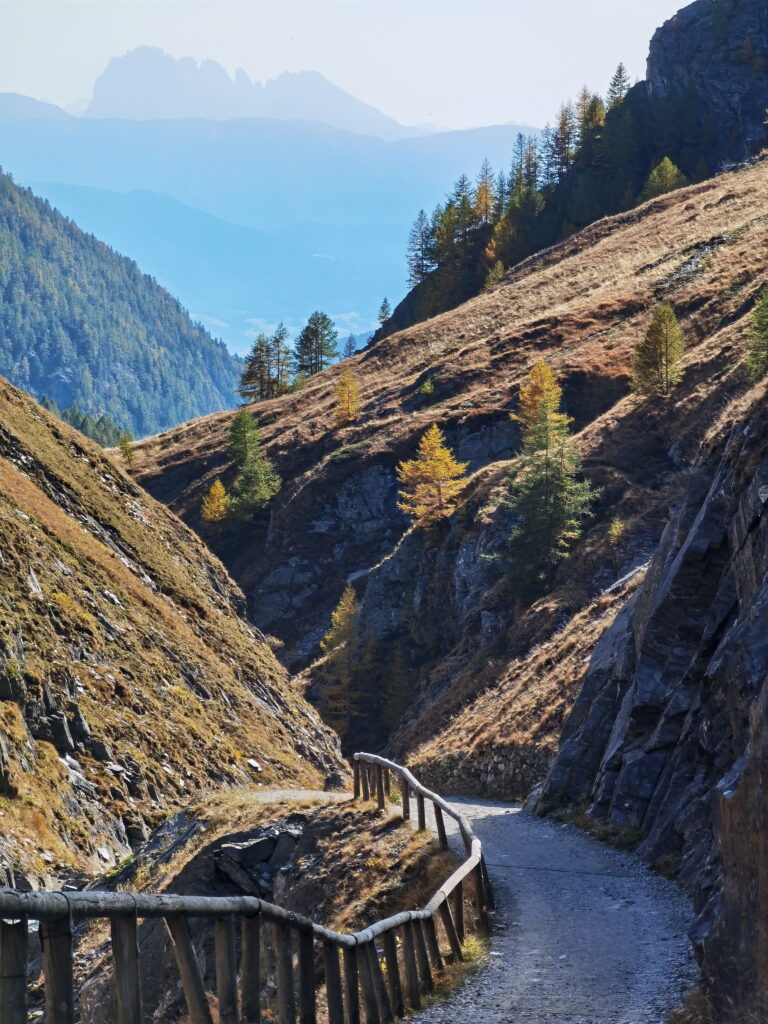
[132,155,768,753]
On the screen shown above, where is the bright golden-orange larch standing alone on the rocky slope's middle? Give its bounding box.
[397,424,469,522]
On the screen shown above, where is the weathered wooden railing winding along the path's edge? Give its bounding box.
[0,754,490,1024]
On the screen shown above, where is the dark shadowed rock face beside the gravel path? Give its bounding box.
[542,388,768,1010]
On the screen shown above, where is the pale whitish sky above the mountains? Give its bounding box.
[0,0,685,128]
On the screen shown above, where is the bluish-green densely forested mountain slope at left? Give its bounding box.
[0,174,238,435]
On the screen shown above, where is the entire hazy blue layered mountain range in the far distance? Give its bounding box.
[0,47,530,352]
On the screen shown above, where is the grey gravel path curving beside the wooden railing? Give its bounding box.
[414,798,697,1024]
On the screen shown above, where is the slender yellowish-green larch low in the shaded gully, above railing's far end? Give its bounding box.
[319,584,360,736]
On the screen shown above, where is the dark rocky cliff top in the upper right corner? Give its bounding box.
[646,0,768,162]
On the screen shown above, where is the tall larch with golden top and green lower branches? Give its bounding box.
[504,365,595,597]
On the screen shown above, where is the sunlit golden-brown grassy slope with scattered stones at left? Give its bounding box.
[0,380,339,884]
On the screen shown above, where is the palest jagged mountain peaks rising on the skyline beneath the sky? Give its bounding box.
[85,46,424,139]
